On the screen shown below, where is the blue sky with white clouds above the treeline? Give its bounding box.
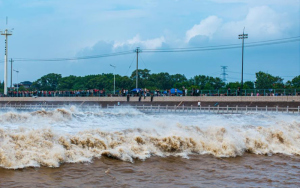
[0,0,300,83]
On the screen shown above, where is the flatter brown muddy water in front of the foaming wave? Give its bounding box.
[0,154,300,187]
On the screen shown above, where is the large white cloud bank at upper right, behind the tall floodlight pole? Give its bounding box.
[186,6,297,42]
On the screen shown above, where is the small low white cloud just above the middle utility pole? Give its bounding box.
[113,35,165,49]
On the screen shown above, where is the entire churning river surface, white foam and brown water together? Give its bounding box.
[0,107,300,187]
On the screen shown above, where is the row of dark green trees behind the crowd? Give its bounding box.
[0,69,300,92]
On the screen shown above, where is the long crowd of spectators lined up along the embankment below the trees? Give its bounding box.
[0,87,300,97]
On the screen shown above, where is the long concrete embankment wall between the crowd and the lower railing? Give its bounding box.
[0,96,300,107]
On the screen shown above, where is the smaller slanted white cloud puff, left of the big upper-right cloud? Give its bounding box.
[186,16,222,42]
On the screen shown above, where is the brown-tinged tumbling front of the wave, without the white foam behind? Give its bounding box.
[0,122,300,169]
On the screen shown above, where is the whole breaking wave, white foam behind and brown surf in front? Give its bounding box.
[0,108,300,169]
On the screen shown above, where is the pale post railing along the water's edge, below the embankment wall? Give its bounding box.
[0,104,300,115]
